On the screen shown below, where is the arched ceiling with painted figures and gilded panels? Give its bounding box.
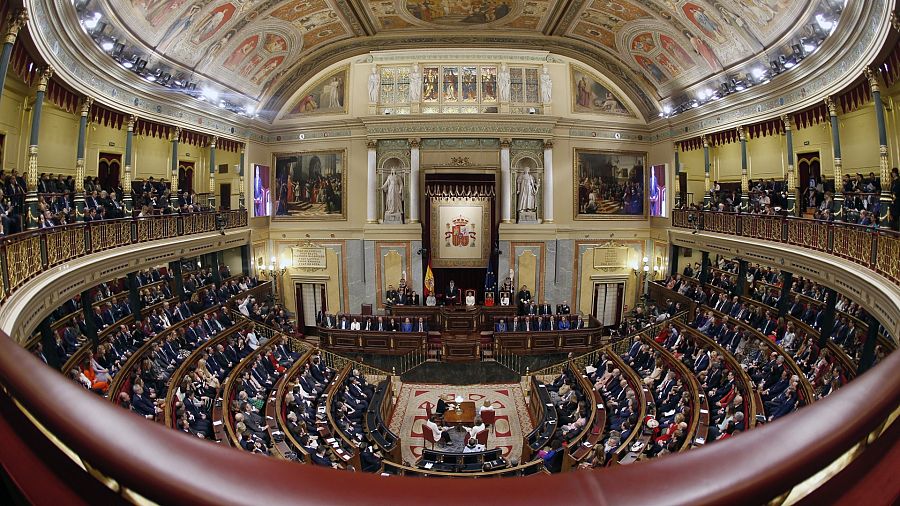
[74,0,828,119]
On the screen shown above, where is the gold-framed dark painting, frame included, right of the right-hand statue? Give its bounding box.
[572,148,649,220]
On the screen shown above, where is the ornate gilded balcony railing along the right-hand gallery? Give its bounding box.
[672,209,900,285]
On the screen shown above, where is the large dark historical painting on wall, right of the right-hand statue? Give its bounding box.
[574,149,647,219]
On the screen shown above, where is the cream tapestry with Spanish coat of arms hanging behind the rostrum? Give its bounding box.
[431,197,491,268]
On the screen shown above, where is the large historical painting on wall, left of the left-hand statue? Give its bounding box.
[273,151,347,220]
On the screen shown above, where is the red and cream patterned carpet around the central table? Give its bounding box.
[390,383,532,464]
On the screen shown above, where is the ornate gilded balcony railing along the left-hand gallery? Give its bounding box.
[0,209,247,300]
